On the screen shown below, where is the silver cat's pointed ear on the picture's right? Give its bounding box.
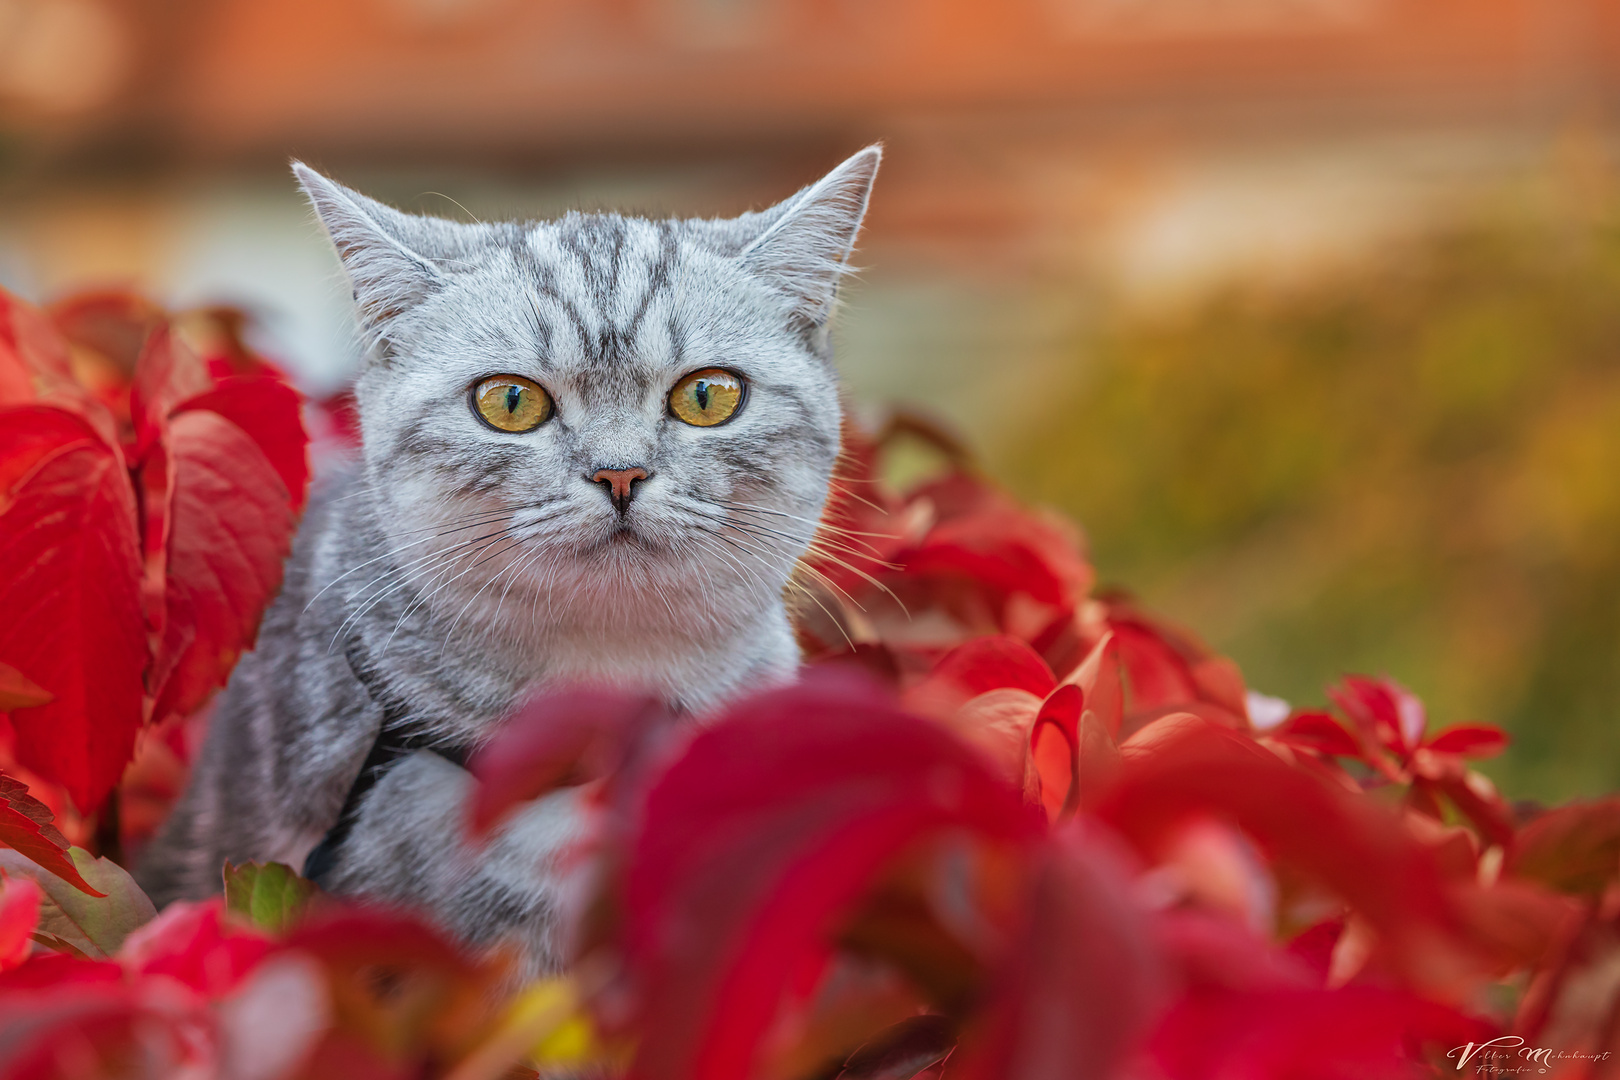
[742,144,883,327]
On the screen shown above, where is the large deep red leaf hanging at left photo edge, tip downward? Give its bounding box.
[0,406,147,813]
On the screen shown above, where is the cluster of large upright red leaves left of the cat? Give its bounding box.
[0,286,308,813]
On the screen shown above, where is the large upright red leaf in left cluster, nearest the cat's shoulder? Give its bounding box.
[152,410,295,721]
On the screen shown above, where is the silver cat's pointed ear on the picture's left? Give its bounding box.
[293,160,454,332]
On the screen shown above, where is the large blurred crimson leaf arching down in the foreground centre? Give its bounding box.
[624,670,1040,1080]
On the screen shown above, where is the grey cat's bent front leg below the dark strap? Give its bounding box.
[322,750,583,978]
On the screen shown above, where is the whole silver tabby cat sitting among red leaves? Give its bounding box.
[138,146,881,975]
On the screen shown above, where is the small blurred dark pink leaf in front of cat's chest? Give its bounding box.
[468,688,667,836]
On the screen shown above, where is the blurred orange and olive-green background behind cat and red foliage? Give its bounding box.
[0,0,1620,798]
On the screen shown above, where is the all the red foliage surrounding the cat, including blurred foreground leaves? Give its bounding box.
[0,293,1620,1080]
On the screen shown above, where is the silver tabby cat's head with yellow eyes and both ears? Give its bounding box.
[293,146,880,647]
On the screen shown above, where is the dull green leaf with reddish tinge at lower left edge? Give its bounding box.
[0,847,157,959]
